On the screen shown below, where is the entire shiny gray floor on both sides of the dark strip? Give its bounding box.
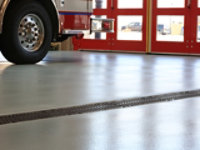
[0,52,200,150]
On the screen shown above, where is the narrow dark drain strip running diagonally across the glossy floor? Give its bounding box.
[0,89,200,125]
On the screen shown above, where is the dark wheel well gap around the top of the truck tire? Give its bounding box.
[5,0,59,40]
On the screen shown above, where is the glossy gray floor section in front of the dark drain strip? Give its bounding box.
[0,98,200,150]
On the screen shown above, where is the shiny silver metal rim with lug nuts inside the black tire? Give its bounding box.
[18,14,45,52]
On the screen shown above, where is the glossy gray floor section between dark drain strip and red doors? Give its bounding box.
[0,52,200,114]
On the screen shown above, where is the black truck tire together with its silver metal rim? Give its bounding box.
[1,0,52,64]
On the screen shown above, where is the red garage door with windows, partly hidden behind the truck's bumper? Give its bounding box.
[78,0,147,52]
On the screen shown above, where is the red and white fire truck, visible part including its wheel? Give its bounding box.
[0,0,114,64]
